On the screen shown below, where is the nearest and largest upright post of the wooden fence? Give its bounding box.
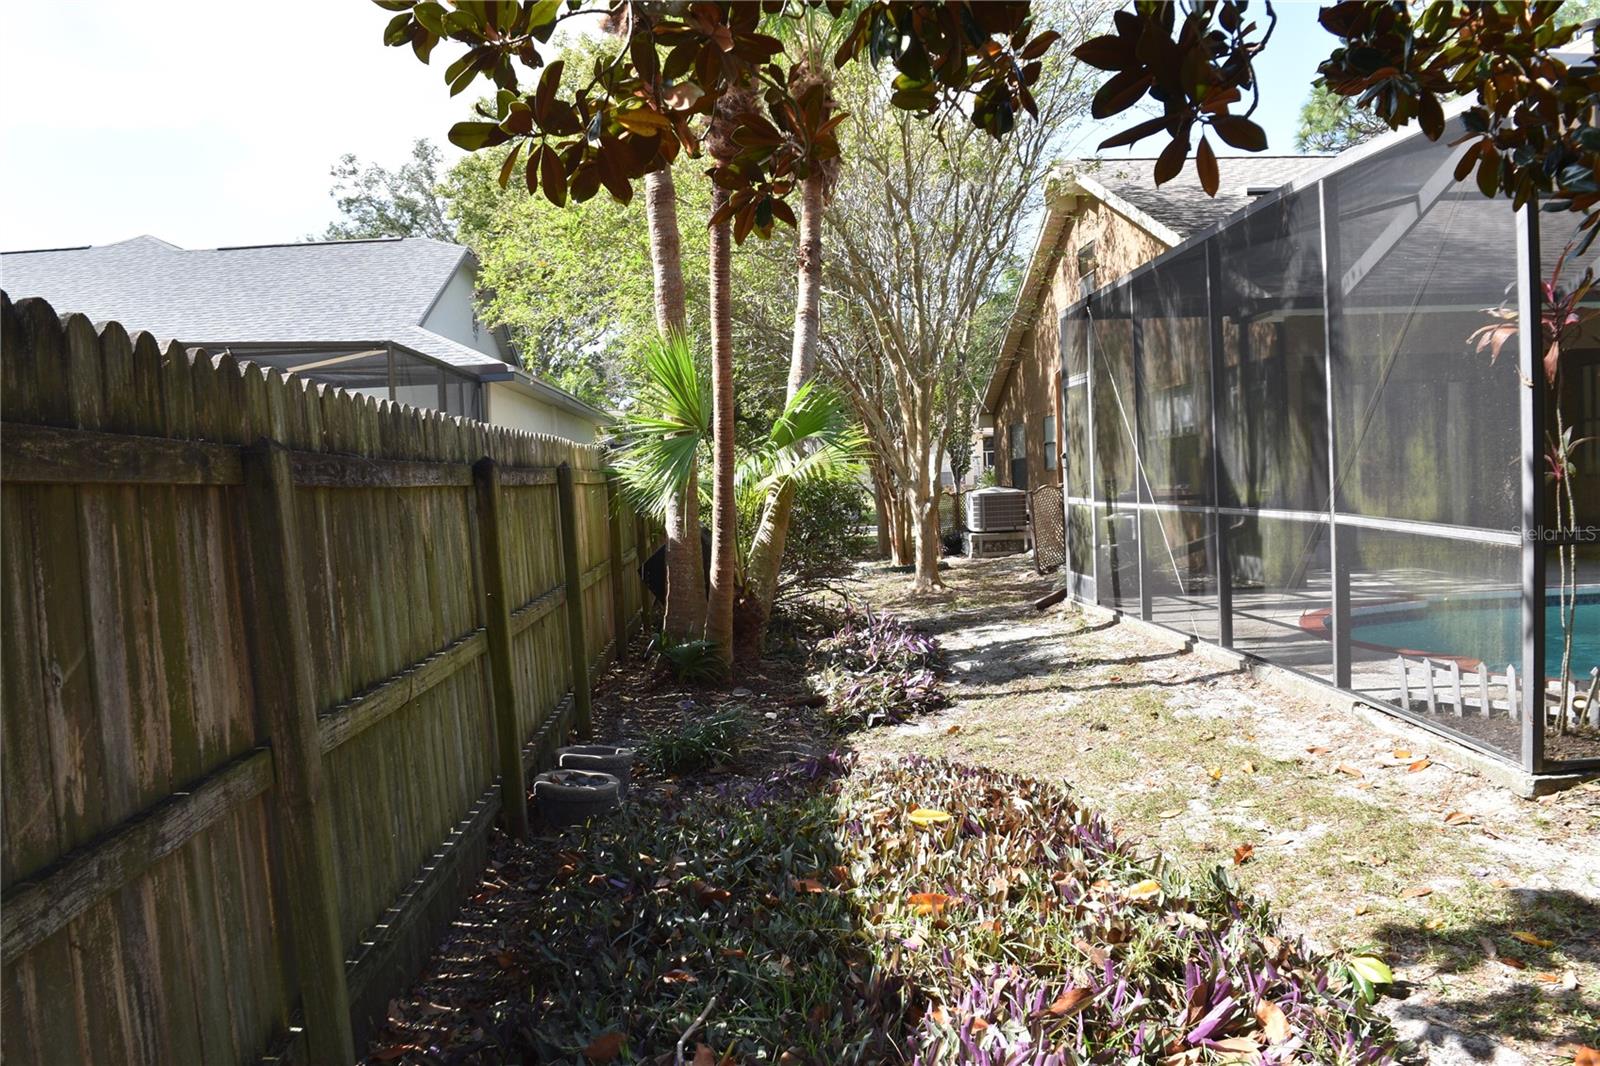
[243,440,355,1063]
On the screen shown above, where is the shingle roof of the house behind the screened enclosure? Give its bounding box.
[1066,155,1330,237]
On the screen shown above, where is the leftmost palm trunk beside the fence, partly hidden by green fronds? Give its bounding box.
[645,168,706,640]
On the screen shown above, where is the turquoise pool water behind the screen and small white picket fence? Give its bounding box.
[1350,586,1600,677]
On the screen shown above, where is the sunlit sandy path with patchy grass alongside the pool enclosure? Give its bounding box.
[850,557,1600,1066]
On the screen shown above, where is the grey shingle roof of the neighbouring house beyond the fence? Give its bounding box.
[0,237,506,371]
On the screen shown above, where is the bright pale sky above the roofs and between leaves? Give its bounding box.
[0,0,1333,250]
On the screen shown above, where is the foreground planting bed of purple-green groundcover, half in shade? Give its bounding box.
[371,601,1394,1066]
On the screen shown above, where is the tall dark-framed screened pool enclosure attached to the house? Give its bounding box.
[1061,120,1600,773]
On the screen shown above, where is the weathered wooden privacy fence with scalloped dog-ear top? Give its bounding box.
[0,295,643,1066]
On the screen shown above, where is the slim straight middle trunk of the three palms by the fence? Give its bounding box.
[706,186,739,663]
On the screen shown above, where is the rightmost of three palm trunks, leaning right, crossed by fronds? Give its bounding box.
[741,174,824,655]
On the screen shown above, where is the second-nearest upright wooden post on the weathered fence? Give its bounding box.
[472,456,528,840]
